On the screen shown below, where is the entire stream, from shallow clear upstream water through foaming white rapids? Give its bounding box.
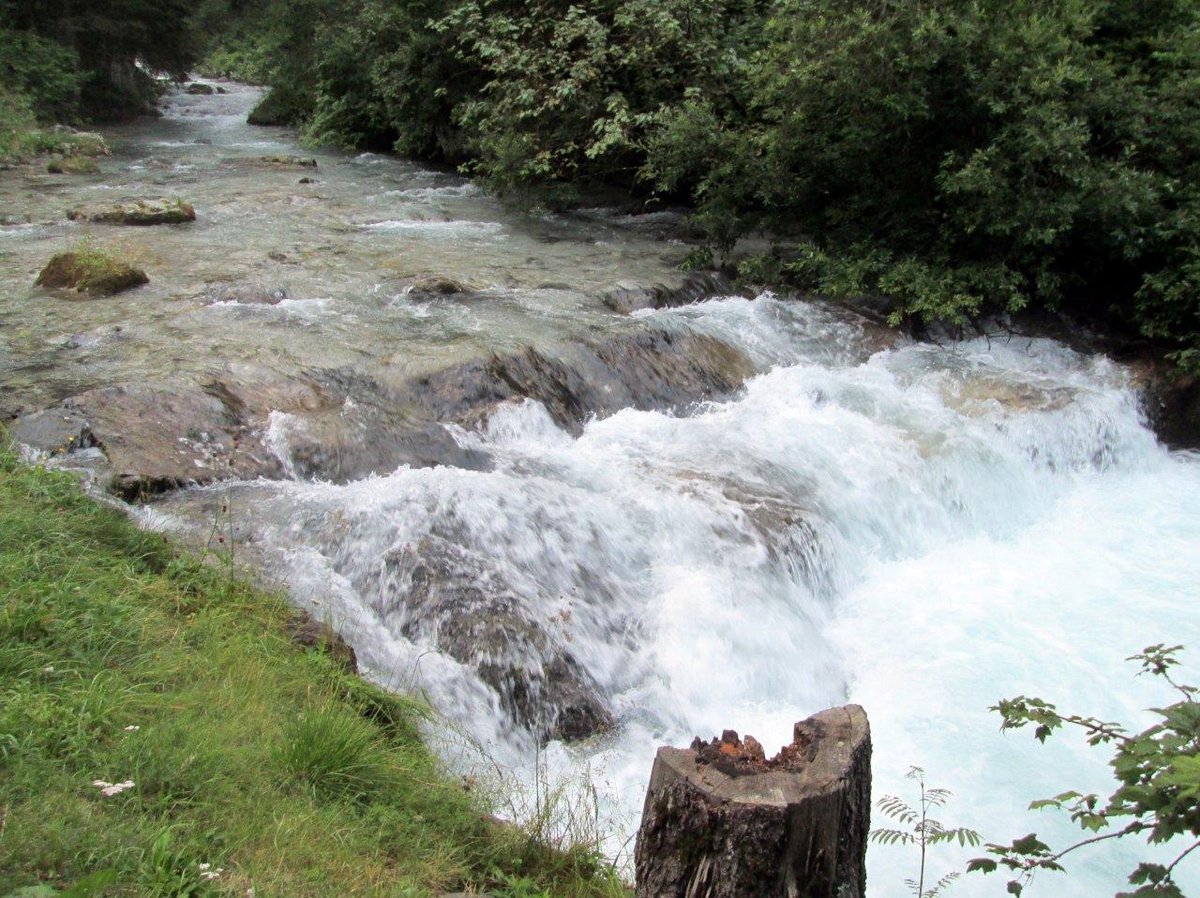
[0,84,1200,898]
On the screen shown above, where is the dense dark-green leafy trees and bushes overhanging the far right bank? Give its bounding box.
[220,0,1200,355]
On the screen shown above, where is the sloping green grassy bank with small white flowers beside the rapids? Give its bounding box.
[0,447,628,898]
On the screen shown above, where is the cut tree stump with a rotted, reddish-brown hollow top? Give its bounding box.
[635,705,871,898]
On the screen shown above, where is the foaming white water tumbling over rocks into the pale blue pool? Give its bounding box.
[187,297,1200,898]
